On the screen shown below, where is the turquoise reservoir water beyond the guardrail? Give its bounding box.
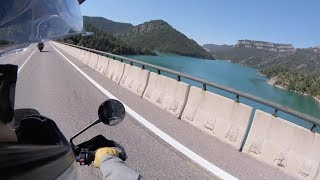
[130,54,320,127]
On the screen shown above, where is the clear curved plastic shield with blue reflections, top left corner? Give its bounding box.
[0,0,85,55]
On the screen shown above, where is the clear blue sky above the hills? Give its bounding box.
[81,0,320,47]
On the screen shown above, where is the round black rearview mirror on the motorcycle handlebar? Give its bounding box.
[98,99,126,126]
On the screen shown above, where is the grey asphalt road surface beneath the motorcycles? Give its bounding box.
[0,43,296,179]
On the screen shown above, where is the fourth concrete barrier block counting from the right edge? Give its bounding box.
[120,64,150,97]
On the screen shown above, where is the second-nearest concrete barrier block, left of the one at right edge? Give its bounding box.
[181,87,253,149]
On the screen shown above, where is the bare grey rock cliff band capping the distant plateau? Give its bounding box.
[235,40,296,53]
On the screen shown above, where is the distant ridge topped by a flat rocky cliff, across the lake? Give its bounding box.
[204,40,320,72]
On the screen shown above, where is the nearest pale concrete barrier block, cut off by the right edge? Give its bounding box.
[242,110,320,179]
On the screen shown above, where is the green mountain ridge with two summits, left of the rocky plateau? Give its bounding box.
[84,16,214,59]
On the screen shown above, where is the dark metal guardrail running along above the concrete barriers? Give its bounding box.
[60,42,320,132]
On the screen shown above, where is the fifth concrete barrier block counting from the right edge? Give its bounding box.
[105,59,125,84]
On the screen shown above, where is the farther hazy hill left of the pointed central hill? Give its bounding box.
[83,16,133,34]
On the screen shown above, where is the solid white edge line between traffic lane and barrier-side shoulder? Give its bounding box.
[50,43,237,179]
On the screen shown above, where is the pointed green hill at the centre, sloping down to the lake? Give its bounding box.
[115,20,214,59]
